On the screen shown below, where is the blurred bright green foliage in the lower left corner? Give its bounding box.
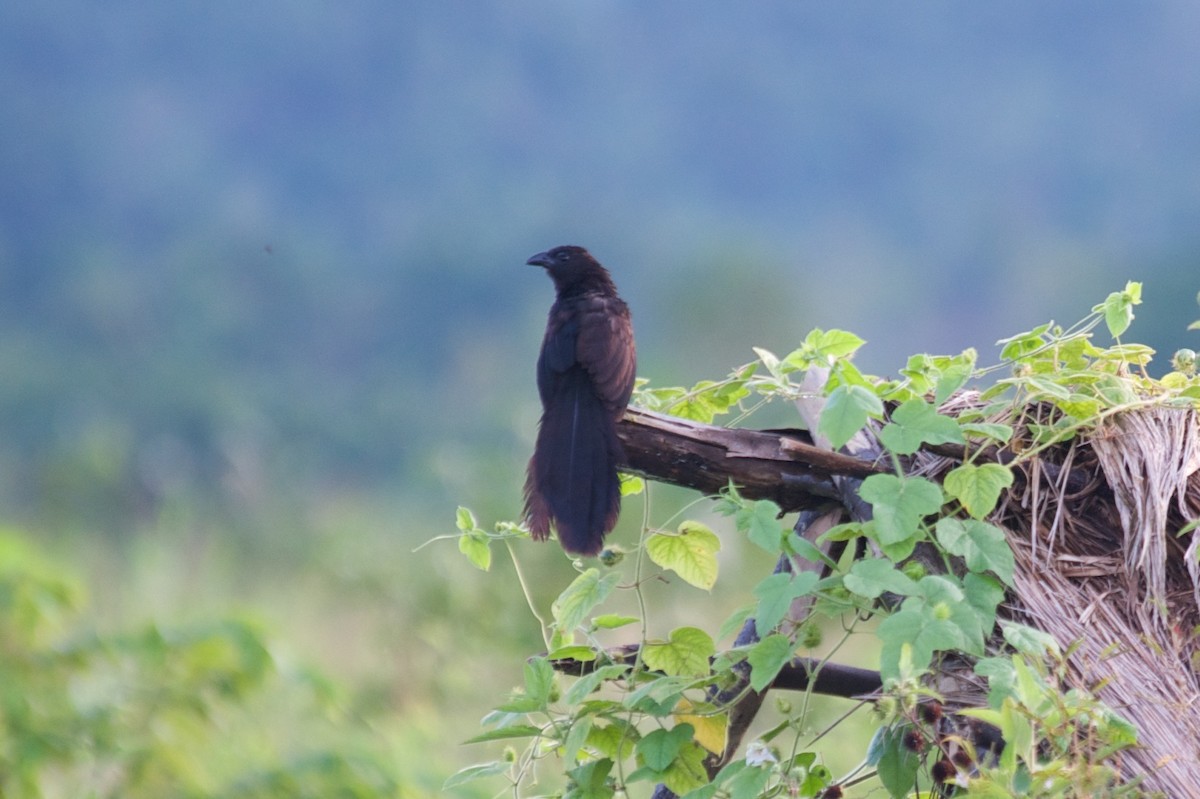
[0,530,412,798]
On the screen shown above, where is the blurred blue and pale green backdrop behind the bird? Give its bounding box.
[0,0,1200,795]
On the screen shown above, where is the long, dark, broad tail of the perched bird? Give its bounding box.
[526,370,624,555]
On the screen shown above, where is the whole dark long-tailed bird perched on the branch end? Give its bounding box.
[526,246,637,555]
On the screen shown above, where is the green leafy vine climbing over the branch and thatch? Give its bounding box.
[451,283,1200,799]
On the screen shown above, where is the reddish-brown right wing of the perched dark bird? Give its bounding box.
[575,295,637,413]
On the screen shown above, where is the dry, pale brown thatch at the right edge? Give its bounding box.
[996,408,1200,797]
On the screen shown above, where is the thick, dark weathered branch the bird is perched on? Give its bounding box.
[617,408,886,512]
